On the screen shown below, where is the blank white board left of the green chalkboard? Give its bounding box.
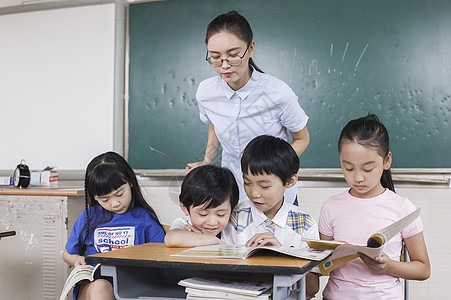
[0,3,116,170]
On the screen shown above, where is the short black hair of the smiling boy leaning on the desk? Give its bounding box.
[179,165,239,211]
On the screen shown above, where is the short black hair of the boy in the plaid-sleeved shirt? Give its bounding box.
[241,135,299,185]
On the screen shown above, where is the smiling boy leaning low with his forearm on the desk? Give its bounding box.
[164,165,238,247]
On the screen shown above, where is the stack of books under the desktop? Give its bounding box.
[179,273,272,300]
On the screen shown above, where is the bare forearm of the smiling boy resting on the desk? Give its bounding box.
[164,229,224,247]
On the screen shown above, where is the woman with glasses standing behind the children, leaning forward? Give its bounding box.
[187,11,309,203]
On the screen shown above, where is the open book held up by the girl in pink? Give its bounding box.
[303,208,420,275]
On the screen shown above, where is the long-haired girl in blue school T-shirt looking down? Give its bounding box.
[63,152,164,299]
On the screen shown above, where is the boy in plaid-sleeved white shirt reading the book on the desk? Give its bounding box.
[222,135,319,296]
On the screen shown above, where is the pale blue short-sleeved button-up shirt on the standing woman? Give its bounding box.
[196,70,308,203]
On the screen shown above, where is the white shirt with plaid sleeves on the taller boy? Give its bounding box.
[221,201,319,248]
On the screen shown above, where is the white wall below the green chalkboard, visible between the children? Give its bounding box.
[140,176,451,300]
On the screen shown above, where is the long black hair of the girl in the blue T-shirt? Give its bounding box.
[78,152,163,255]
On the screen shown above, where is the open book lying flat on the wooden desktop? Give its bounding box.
[171,245,332,260]
